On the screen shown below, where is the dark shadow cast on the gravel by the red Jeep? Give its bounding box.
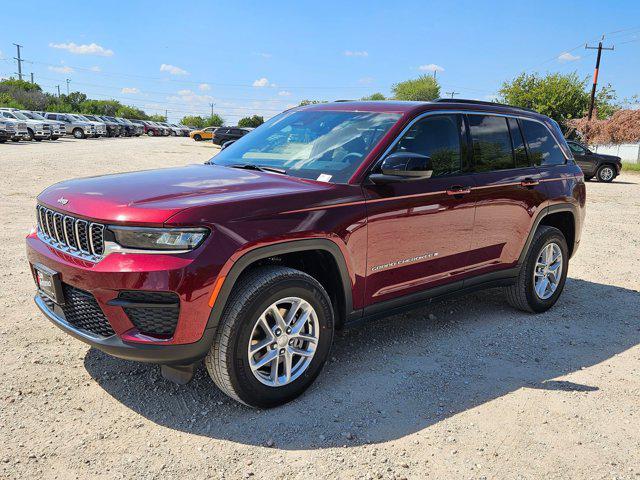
[84,279,640,450]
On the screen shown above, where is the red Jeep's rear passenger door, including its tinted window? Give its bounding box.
[465,114,546,278]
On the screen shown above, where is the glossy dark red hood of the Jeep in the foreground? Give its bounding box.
[38,165,331,224]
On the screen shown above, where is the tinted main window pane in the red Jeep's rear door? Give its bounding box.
[469,115,514,172]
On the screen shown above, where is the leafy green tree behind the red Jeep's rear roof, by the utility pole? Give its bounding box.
[499,72,619,124]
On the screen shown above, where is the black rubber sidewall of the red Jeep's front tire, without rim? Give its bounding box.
[227,275,333,408]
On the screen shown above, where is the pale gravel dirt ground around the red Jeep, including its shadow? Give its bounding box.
[0,138,640,480]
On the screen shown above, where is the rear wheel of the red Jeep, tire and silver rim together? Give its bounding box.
[505,225,569,313]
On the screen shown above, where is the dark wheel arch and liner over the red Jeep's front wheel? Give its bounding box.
[207,238,353,329]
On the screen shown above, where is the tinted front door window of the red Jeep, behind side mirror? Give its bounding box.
[393,115,464,177]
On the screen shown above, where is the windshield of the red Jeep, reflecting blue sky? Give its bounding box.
[210,110,400,183]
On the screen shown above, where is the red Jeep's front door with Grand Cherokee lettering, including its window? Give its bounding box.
[364,114,475,305]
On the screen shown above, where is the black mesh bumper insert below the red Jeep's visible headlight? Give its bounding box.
[118,290,180,336]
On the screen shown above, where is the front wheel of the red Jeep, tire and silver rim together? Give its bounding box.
[205,266,334,408]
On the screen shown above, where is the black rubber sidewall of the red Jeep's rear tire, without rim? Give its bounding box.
[525,228,569,313]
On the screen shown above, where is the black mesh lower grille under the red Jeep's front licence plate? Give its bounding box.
[39,283,116,337]
